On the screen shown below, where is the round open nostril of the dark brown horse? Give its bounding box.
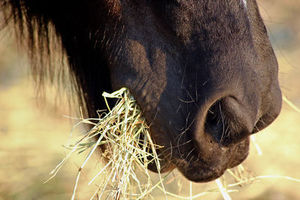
[204,97,254,146]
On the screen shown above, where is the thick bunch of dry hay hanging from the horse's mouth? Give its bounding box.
[50,88,168,199]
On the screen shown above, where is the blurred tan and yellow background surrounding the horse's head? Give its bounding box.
[0,0,300,200]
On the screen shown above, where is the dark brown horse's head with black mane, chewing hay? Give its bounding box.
[0,0,282,182]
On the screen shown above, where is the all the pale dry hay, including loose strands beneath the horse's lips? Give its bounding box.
[49,88,299,200]
